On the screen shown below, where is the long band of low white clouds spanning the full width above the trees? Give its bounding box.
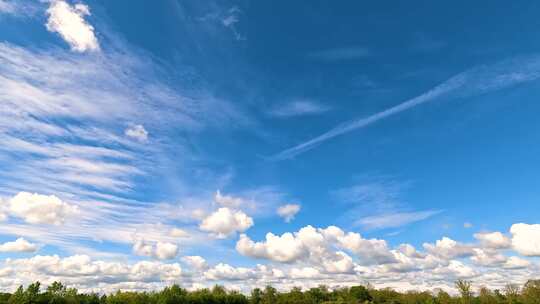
[0,221,540,291]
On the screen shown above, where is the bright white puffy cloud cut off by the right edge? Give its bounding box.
[510,223,540,256]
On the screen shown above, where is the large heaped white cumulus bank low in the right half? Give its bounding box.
[236,222,538,285]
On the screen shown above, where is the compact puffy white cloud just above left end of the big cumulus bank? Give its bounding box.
[199,207,253,238]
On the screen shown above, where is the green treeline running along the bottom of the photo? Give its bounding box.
[0,280,540,304]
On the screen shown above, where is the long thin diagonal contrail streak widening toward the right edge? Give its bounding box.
[270,55,540,160]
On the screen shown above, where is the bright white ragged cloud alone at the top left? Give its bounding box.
[46,0,99,52]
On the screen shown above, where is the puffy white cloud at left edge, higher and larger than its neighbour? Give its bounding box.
[9,192,79,225]
